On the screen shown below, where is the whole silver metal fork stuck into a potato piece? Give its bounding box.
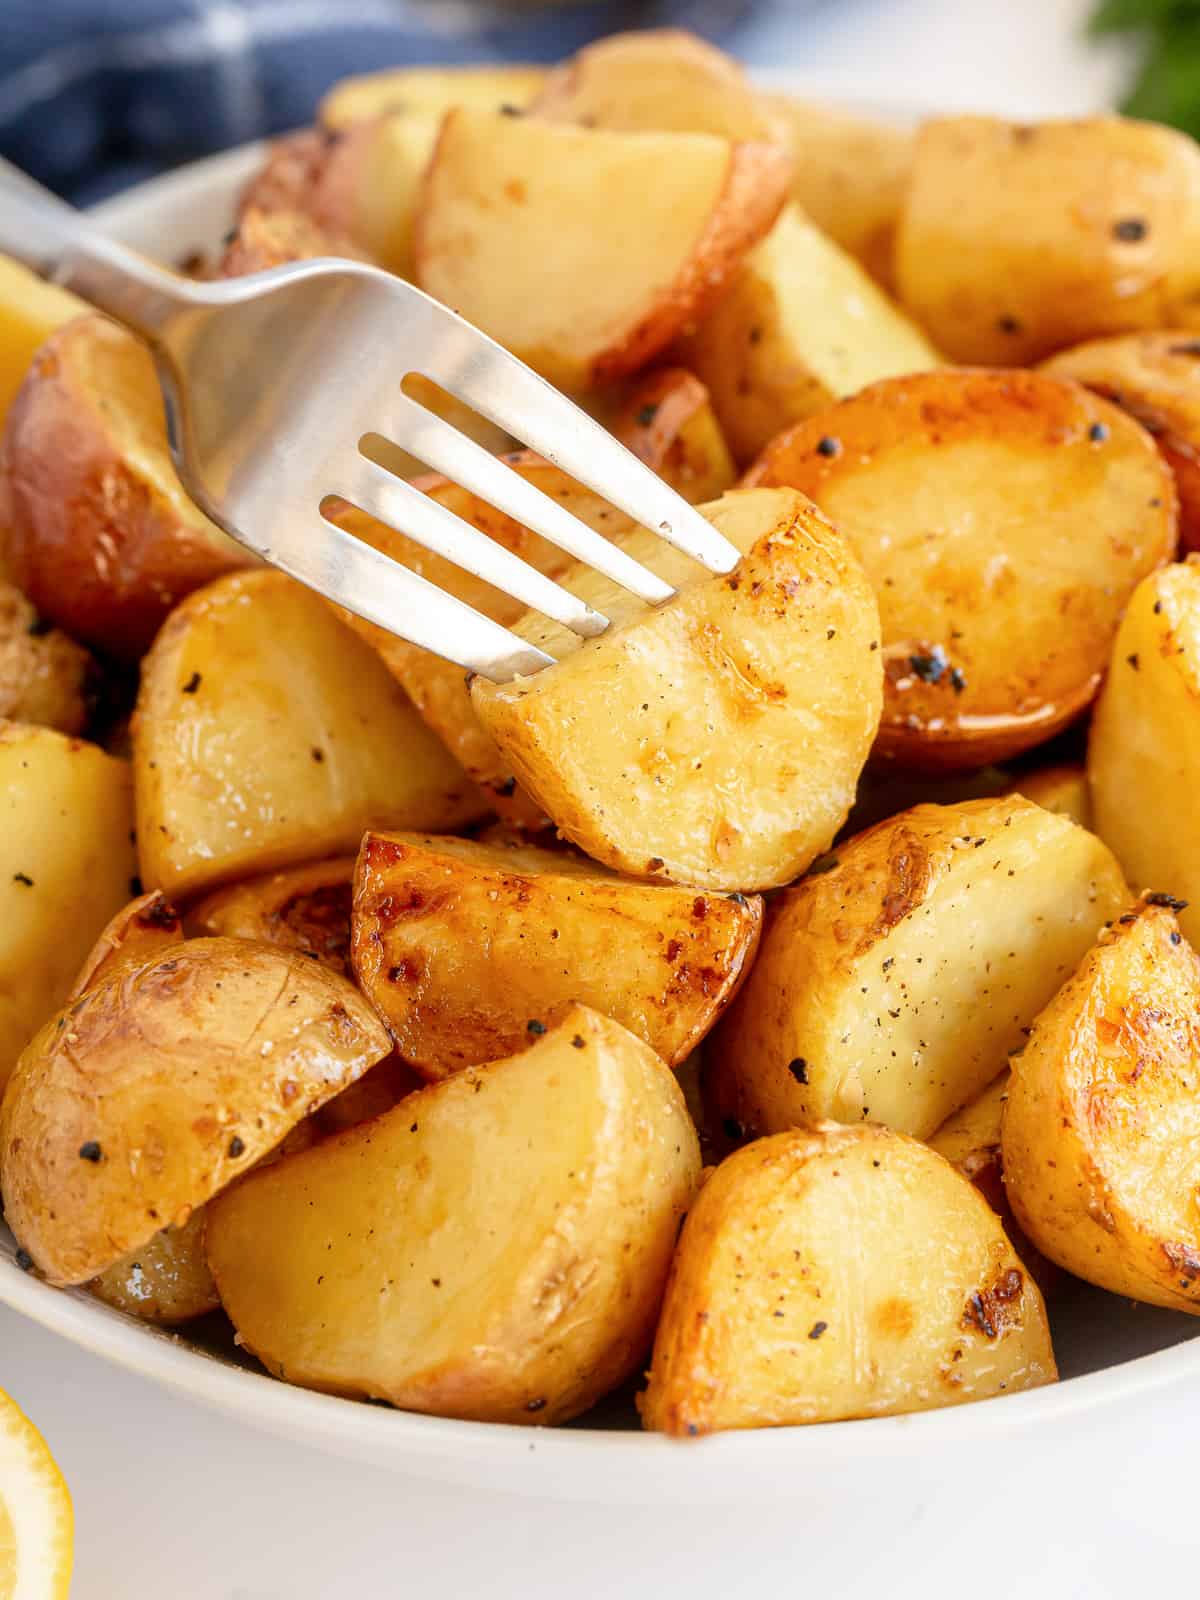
[0,162,738,682]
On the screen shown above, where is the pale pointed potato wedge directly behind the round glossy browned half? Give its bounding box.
[674,205,938,464]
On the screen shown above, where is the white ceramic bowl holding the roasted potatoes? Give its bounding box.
[0,112,1200,1504]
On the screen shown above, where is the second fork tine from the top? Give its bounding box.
[381,394,675,605]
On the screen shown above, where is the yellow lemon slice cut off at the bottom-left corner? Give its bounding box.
[0,1389,75,1600]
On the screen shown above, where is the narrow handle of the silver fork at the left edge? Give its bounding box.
[0,157,184,339]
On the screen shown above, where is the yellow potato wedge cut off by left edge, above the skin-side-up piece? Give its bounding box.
[0,723,138,1090]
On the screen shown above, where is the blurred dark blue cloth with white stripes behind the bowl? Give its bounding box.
[0,0,774,205]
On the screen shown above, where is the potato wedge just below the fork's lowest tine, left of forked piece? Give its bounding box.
[133,570,486,896]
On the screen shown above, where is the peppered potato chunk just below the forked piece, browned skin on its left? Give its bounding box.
[709,795,1130,1139]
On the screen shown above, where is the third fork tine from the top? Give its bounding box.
[330,456,608,638]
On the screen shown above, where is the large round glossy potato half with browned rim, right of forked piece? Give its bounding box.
[746,371,1176,770]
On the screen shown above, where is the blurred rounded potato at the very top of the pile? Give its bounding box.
[530,27,787,146]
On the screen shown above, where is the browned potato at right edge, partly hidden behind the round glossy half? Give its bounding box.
[1042,331,1200,550]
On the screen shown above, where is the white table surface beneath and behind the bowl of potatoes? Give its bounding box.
[0,0,1200,1600]
